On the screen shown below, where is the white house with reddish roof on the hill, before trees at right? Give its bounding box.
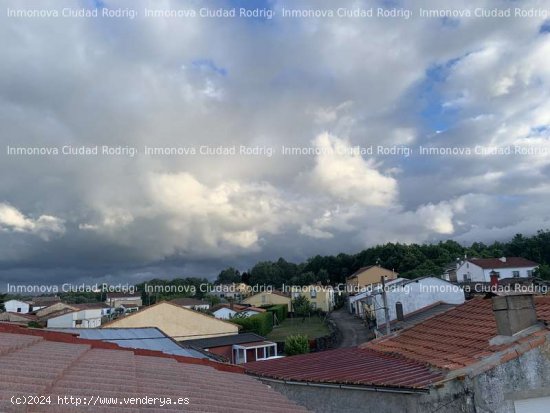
[456,257,538,282]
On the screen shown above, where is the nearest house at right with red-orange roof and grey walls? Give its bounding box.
[244,295,550,413]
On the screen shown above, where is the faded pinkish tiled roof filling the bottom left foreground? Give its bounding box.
[0,325,306,413]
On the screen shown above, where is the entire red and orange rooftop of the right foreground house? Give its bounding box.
[244,296,550,391]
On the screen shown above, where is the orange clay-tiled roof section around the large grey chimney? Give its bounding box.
[361,297,550,370]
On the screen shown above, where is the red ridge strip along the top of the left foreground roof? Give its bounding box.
[0,323,244,373]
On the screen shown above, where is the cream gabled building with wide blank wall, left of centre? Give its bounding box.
[102,301,239,341]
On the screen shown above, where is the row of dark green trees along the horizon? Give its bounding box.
[216,230,550,287]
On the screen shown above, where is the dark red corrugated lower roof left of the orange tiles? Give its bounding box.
[243,347,443,389]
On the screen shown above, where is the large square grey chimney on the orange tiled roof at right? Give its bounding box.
[493,294,537,336]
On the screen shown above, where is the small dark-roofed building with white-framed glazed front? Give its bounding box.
[184,333,277,364]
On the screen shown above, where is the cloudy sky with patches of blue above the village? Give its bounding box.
[0,0,550,284]
